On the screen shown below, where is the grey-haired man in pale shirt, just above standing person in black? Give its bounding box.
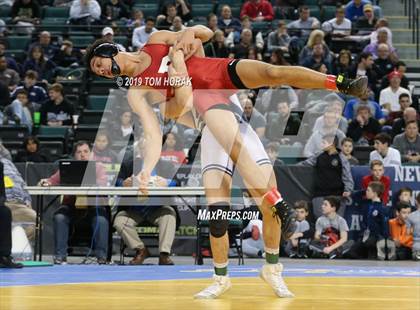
[303,108,346,157]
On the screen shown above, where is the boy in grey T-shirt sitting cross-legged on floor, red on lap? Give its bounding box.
[309,196,353,259]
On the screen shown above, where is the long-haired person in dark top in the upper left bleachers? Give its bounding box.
[23,45,57,83]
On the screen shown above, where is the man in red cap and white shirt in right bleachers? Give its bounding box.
[379,70,412,112]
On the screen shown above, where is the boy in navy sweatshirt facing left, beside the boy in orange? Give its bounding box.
[362,181,391,260]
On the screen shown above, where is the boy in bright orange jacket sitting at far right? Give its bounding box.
[389,203,413,260]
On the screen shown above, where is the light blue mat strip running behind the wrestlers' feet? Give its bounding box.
[0,264,420,287]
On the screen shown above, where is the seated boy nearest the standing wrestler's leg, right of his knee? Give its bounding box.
[285,200,314,258]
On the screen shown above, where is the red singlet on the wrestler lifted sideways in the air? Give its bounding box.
[137,44,246,115]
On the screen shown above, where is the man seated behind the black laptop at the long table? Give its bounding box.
[39,141,109,265]
